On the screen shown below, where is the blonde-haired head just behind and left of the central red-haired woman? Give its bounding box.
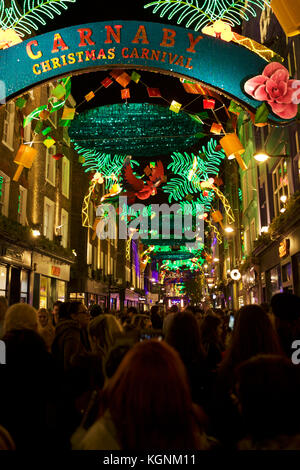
[88,314,123,357]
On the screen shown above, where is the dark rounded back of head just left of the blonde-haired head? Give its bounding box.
[52,319,89,370]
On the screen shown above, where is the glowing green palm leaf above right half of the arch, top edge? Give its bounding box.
[144,0,270,31]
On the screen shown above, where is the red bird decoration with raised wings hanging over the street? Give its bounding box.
[124,160,166,203]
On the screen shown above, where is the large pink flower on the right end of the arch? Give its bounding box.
[244,62,300,119]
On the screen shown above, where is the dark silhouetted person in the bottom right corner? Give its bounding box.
[236,355,300,450]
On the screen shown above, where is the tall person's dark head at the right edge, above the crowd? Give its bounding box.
[271,293,300,358]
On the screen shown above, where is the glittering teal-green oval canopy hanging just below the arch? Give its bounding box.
[69,103,203,157]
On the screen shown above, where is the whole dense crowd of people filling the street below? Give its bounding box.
[0,293,300,451]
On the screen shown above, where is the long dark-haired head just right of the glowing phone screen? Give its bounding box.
[222,305,282,371]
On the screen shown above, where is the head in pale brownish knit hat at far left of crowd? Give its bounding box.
[4,304,38,333]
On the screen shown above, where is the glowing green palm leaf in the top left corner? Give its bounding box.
[0,0,76,37]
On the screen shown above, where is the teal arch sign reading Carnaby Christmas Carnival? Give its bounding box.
[0,21,284,120]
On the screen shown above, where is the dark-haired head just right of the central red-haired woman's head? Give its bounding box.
[165,313,203,364]
